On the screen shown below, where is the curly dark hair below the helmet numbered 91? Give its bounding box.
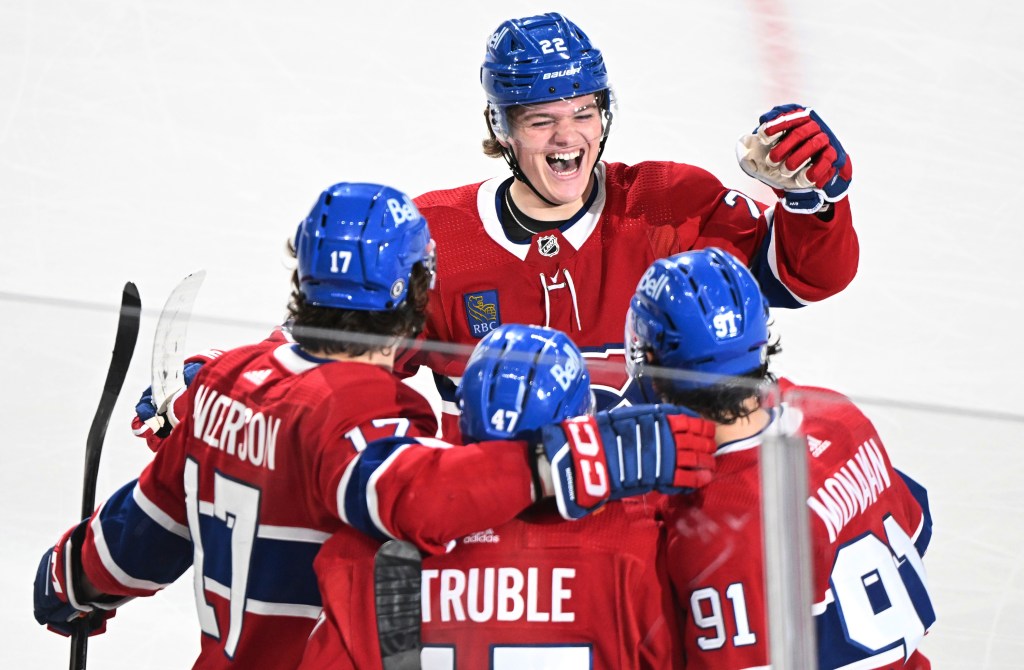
[651,339,782,423]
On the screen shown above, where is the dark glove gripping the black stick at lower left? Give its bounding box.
[34,519,116,636]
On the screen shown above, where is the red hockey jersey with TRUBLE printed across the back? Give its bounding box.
[301,499,682,670]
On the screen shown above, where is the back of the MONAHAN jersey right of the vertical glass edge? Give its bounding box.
[781,380,935,669]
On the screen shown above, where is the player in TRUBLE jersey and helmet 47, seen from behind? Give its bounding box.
[302,324,713,670]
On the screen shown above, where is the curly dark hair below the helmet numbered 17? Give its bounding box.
[288,263,431,357]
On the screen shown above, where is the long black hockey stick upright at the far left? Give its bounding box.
[71,282,142,670]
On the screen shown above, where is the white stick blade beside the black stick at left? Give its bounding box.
[153,269,206,415]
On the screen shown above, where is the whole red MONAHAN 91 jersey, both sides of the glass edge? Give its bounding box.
[666,380,935,670]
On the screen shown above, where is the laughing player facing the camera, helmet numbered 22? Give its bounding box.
[398,13,859,438]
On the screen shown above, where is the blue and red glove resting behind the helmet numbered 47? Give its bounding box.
[539,405,715,519]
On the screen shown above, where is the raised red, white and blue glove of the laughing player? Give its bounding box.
[736,104,853,214]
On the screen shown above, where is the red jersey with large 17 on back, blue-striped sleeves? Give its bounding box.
[76,338,531,668]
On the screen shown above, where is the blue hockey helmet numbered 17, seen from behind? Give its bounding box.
[295,182,434,311]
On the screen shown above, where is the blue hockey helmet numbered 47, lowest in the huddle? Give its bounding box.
[456,324,593,442]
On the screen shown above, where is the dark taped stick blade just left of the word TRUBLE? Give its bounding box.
[374,540,422,670]
